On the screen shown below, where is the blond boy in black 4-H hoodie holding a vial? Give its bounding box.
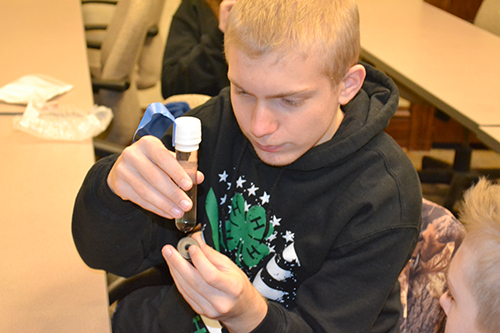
[73,0,422,332]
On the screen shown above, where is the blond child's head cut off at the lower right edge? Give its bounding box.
[440,179,500,333]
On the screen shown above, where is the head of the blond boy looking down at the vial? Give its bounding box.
[224,0,366,166]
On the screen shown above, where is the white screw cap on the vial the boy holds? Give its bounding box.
[174,116,201,152]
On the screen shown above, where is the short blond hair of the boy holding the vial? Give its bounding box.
[224,0,360,85]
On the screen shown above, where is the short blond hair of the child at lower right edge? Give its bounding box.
[460,178,500,332]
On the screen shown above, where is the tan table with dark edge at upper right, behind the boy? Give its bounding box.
[357,0,500,132]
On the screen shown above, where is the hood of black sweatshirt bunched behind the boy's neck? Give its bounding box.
[285,64,399,170]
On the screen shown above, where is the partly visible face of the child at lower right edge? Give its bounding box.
[439,242,478,333]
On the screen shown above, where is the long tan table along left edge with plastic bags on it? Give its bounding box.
[0,0,110,333]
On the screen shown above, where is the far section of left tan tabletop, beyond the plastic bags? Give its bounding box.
[0,0,93,112]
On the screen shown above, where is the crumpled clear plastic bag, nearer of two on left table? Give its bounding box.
[14,99,113,141]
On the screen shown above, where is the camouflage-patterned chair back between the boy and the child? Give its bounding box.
[399,199,465,332]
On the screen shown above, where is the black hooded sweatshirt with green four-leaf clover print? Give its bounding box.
[73,66,422,332]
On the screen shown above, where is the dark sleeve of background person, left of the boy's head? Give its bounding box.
[161,0,229,98]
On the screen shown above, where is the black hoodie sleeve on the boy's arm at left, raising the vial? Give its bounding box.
[72,156,180,277]
